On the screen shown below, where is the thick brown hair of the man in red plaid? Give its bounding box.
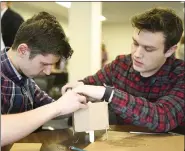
[131,7,183,52]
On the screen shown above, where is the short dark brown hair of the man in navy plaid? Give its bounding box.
[12,12,73,59]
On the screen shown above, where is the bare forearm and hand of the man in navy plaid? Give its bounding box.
[1,90,87,146]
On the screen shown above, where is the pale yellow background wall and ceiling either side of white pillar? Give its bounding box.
[11,2,184,62]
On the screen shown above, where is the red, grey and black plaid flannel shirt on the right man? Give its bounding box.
[82,55,185,132]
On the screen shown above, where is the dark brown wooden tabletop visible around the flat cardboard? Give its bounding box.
[1,125,184,151]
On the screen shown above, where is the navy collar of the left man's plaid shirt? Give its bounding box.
[1,47,26,85]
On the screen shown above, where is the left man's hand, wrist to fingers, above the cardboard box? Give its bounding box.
[54,90,87,116]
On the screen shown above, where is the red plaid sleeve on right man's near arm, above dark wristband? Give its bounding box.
[110,74,185,132]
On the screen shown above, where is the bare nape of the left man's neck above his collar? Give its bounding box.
[7,48,20,72]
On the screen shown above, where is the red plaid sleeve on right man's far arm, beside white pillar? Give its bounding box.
[81,56,122,86]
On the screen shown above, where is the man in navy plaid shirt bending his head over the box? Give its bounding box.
[1,12,87,146]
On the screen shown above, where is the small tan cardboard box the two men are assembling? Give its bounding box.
[73,102,109,132]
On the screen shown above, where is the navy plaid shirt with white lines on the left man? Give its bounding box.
[1,48,54,114]
